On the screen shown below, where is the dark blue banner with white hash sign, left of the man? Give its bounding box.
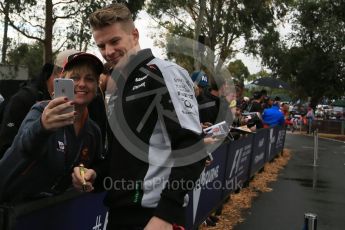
[10,193,107,230]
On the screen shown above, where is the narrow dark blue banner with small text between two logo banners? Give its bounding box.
[250,129,269,177]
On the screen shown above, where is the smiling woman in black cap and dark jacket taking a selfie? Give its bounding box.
[0,52,103,202]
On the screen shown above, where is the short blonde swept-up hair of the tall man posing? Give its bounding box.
[89,3,135,31]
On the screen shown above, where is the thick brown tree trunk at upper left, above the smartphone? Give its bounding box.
[43,0,54,63]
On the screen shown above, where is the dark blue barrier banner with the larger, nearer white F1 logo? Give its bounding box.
[222,134,254,198]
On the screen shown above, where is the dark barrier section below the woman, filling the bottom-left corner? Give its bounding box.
[0,190,107,230]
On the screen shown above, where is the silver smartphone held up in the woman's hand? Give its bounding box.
[54,78,74,113]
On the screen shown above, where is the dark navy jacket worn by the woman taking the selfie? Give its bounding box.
[0,102,102,203]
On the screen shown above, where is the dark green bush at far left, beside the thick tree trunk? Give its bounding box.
[8,42,43,79]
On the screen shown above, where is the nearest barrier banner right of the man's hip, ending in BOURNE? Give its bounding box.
[186,144,228,229]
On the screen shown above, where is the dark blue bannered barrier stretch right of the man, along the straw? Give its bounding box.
[186,126,286,229]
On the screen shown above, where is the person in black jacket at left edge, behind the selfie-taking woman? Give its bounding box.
[0,63,55,159]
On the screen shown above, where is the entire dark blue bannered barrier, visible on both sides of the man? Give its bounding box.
[0,126,286,230]
